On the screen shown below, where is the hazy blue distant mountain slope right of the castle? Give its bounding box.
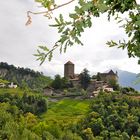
[114,69,140,91]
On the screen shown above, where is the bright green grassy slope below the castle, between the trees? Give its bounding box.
[41,99,90,125]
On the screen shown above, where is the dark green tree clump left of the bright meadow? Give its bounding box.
[0,93,47,114]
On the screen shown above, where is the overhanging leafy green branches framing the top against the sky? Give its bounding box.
[26,0,140,64]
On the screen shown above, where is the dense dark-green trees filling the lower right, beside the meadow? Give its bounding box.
[79,93,140,140]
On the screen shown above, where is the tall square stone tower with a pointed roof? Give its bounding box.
[64,61,74,79]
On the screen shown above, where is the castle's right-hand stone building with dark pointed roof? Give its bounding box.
[98,70,118,83]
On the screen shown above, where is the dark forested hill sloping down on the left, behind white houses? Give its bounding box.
[0,62,51,90]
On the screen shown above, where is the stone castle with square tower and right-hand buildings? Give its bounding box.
[64,61,118,91]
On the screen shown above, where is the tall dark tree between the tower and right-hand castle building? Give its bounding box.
[80,69,91,90]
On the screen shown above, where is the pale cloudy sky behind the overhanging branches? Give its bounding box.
[0,0,140,76]
